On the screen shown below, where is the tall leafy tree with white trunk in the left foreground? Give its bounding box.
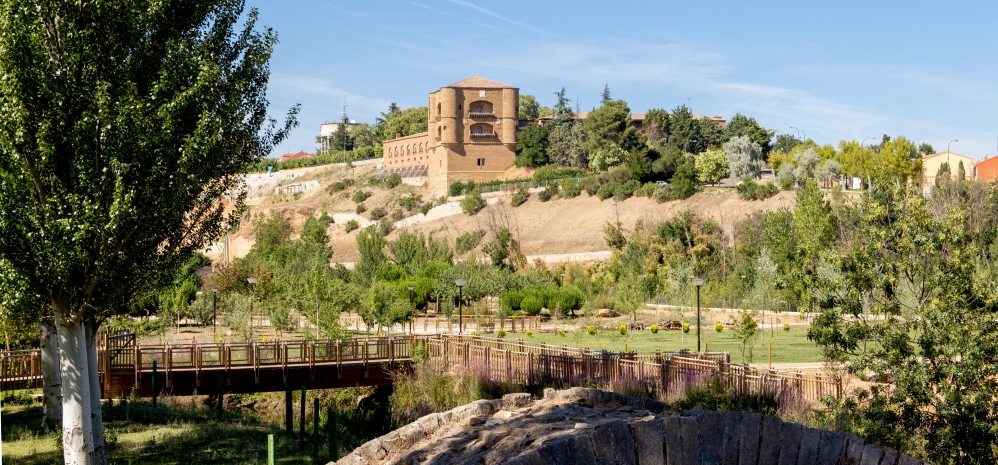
[0,0,293,464]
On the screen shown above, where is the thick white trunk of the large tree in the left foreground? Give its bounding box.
[56,321,94,465]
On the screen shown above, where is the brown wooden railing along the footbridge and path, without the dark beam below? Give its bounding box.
[0,335,842,401]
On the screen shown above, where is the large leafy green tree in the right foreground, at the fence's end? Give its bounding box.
[808,186,998,464]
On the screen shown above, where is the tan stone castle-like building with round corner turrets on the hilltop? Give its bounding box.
[383,76,519,194]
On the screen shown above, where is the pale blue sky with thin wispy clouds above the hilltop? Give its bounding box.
[254,0,998,158]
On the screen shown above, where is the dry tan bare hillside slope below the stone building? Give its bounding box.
[209,162,794,263]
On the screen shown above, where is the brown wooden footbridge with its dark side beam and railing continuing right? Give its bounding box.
[0,335,842,400]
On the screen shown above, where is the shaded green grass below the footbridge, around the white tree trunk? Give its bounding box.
[2,390,385,465]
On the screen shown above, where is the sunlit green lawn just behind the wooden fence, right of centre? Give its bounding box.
[506,325,822,363]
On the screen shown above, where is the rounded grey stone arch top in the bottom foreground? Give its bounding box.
[336,388,922,465]
